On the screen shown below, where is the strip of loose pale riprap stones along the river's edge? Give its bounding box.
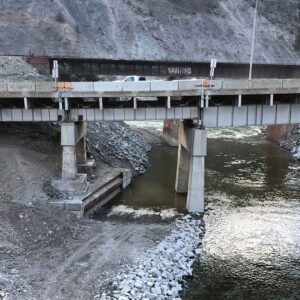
[95,215,204,300]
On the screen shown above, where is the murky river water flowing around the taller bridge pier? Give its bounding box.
[119,123,300,300]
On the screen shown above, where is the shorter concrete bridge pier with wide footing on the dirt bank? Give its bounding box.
[52,122,88,194]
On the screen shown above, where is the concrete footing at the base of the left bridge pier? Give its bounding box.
[51,174,89,195]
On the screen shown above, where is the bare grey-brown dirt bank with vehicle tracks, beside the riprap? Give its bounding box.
[0,127,173,300]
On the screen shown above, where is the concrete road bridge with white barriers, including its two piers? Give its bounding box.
[0,79,300,212]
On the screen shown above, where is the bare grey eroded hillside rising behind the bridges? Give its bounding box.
[0,0,300,63]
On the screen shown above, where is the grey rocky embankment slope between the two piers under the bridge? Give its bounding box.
[88,122,151,175]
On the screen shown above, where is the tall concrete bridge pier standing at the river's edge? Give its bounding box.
[175,121,207,213]
